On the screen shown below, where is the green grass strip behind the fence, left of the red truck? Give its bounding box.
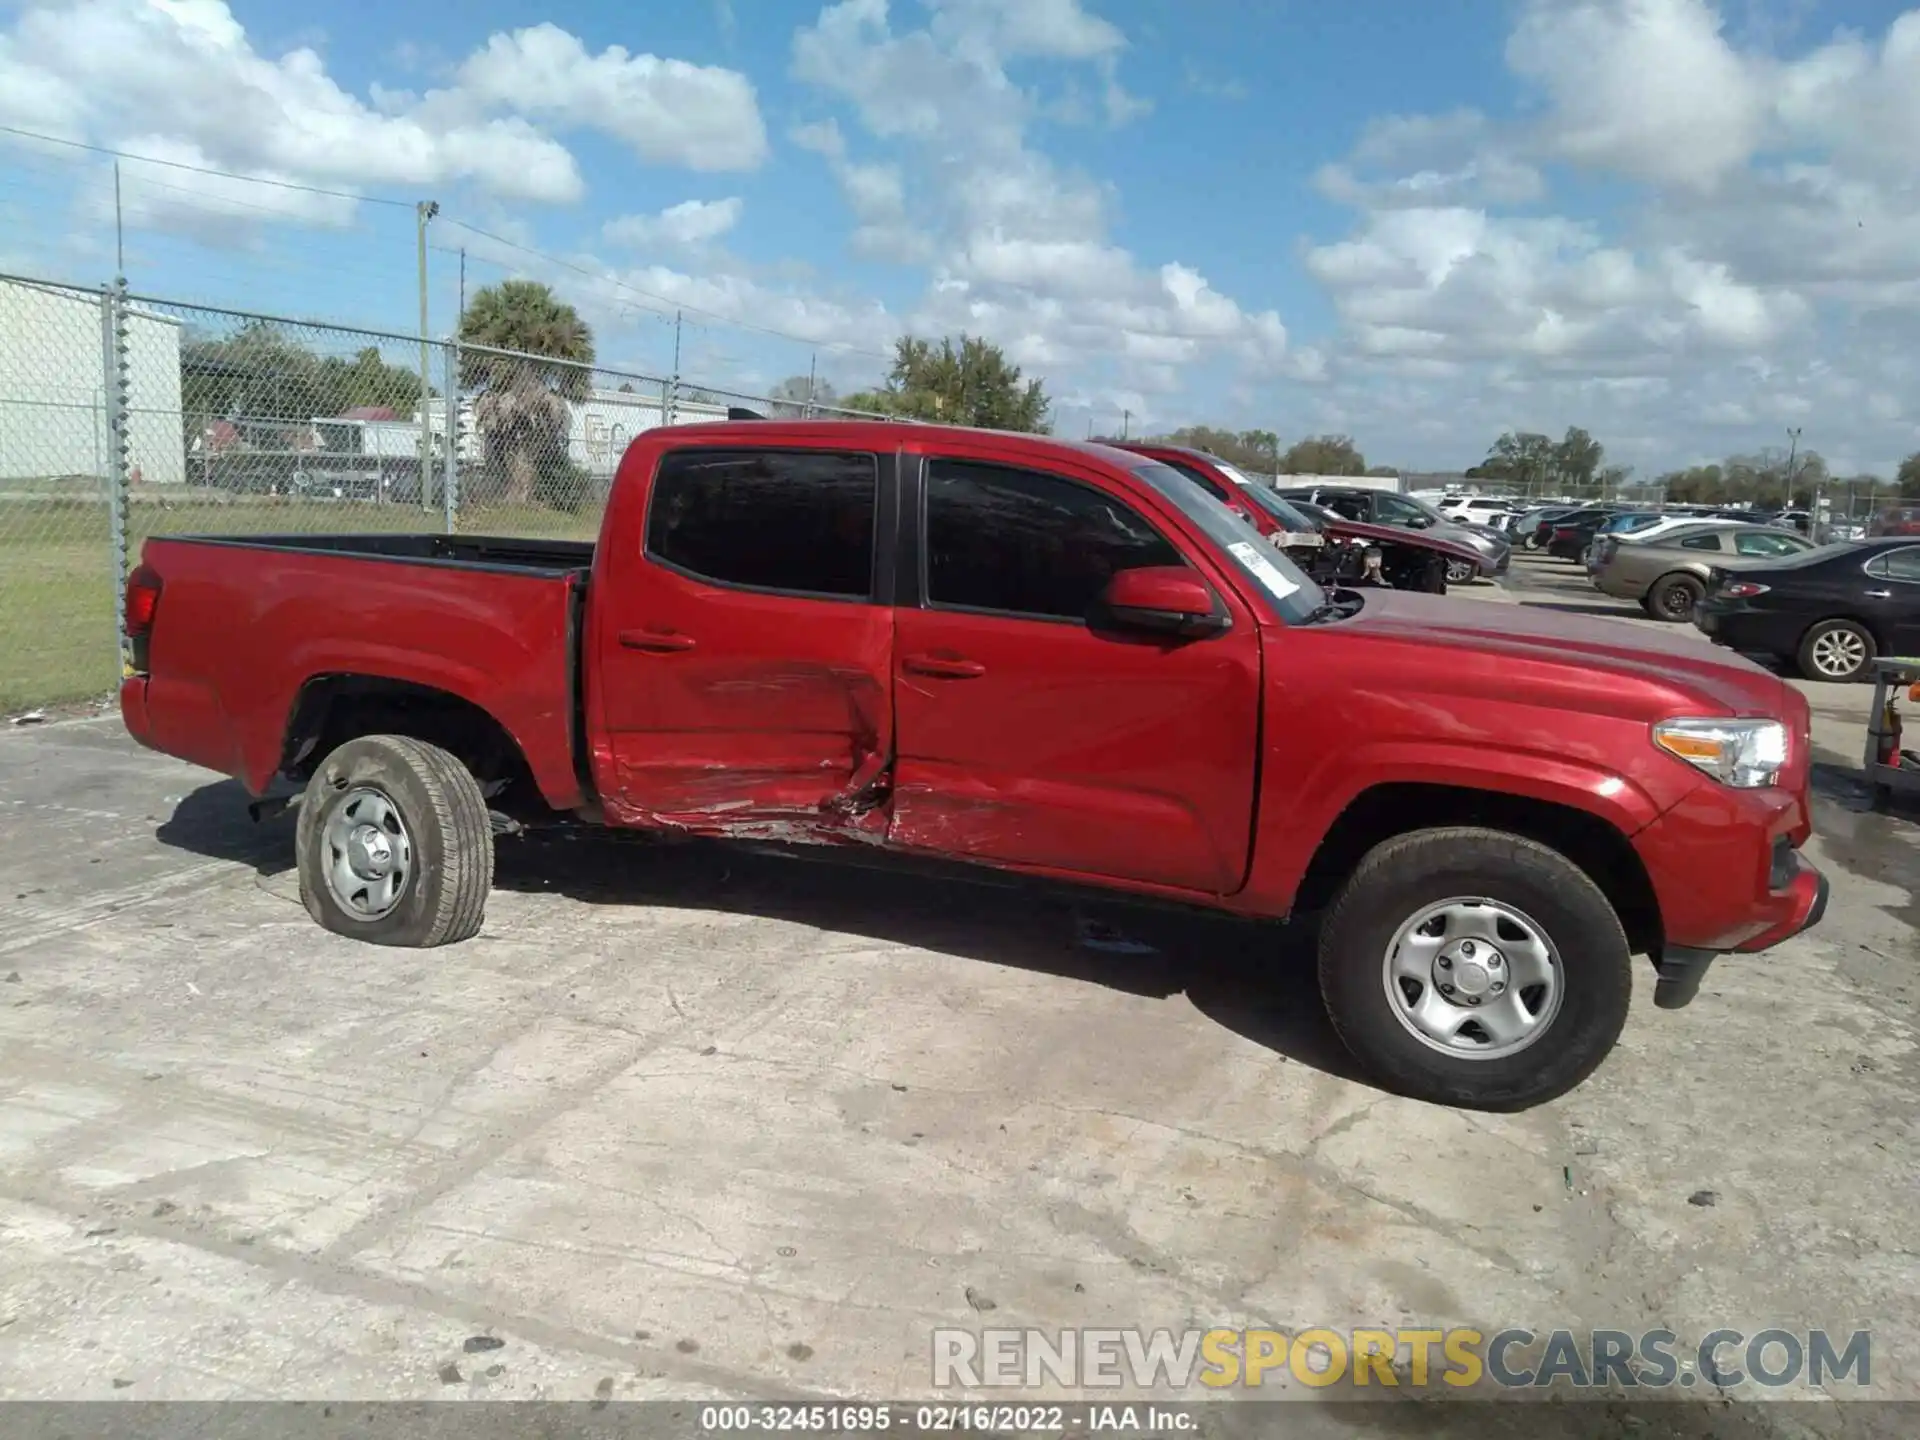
[0,495,599,714]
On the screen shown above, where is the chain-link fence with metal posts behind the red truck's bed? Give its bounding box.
[0,275,940,714]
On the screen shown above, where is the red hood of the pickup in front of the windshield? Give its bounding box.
[1329,589,1797,718]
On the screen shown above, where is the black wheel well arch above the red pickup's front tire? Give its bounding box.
[1294,783,1661,954]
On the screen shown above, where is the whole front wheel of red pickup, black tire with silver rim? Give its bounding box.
[1319,826,1634,1112]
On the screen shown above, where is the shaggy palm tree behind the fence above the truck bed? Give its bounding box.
[461,280,593,505]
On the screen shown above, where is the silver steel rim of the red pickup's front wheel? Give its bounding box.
[1380,895,1567,1060]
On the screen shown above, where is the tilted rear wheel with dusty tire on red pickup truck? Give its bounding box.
[294,735,493,948]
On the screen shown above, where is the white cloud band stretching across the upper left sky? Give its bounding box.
[0,0,766,223]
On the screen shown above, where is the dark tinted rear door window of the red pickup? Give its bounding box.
[647,449,879,599]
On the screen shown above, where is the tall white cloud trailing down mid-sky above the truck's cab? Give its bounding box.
[793,0,1286,407]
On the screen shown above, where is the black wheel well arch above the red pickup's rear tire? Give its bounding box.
[280,676,543,810]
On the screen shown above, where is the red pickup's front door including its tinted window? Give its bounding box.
[889,453,1261,895]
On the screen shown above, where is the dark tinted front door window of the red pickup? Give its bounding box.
[927,459,1187,620]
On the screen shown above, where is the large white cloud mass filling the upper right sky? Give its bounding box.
[1304,0,1920,467]
